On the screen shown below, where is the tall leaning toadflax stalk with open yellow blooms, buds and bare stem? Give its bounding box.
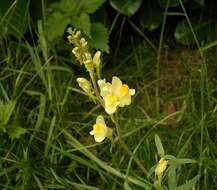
[68,28,147,174]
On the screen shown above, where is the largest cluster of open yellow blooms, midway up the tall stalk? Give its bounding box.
[98,76,135,114]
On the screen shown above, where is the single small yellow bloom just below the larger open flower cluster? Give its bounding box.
[90,115,112,142]
